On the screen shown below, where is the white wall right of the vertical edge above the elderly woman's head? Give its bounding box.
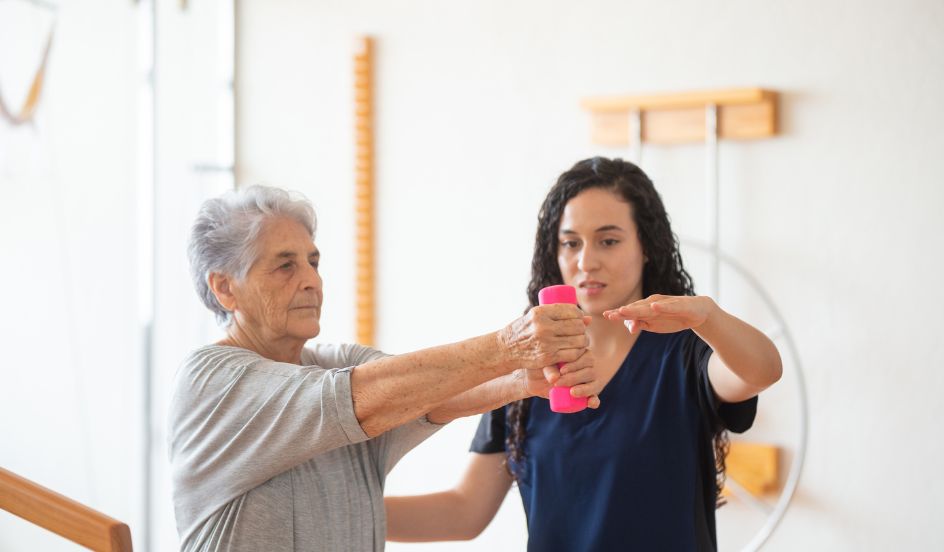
[237,0,944,550]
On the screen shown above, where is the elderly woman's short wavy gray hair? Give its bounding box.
[187,186,317,325]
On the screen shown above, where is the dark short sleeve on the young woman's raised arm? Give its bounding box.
[683,330,757,433]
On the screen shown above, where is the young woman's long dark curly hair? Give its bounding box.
[505,157,729,504]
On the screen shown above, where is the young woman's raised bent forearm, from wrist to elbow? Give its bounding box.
[694,307,783,395]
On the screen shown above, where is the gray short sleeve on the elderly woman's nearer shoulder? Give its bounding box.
[168,346,368,532]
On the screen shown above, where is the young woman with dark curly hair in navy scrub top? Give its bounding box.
[386,157,782,552]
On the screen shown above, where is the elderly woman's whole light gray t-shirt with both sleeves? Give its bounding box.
[168,345,441,552]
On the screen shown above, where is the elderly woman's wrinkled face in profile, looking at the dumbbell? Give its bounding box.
[233,217,322,340]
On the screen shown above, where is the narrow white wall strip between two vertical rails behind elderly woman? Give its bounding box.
[148,0,233,551]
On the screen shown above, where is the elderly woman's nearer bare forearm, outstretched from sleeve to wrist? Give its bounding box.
[351,333,513,437]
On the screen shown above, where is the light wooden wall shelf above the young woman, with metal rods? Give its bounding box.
[581,88,778,147]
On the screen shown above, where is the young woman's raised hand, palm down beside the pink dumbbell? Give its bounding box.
[603,295,718,334]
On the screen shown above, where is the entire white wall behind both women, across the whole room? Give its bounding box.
[0,0,944,550]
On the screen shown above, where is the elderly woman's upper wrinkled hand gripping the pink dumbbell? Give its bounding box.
[498,304,591,369]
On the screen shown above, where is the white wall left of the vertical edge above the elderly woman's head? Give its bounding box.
[0,0,233,551]
